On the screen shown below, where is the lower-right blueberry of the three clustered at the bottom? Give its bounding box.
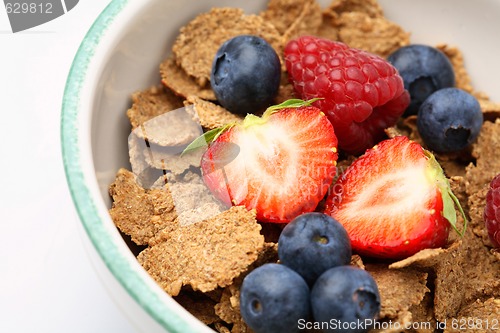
[311,266,380,332]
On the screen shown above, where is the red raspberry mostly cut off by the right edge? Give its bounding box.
[483,174,500,248]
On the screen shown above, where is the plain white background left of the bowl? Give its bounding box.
[0,0,140,333]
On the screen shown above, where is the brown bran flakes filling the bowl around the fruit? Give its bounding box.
[109,0,500,333]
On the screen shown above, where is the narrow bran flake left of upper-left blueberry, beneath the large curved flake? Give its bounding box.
[160,58,217,101]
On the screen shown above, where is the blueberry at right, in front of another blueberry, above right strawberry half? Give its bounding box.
[417,88,483,153]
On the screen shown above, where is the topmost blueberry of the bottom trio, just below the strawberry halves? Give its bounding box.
[278,213,352,285]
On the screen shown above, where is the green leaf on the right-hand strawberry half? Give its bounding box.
[424,150,467,237]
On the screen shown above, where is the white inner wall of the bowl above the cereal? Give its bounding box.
[68,0,500,330]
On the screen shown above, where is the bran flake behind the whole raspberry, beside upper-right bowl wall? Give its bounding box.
[339,12,410,57]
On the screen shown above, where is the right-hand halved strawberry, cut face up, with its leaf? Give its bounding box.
[325,136,466,259]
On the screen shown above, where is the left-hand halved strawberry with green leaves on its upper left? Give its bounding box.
[195,100,337,223]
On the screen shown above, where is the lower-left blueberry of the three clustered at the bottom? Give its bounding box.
[240,264,310,333]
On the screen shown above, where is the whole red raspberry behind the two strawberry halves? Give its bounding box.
[285,36,410,154]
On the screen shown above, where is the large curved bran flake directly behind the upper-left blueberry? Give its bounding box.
[172,8,282,87]
